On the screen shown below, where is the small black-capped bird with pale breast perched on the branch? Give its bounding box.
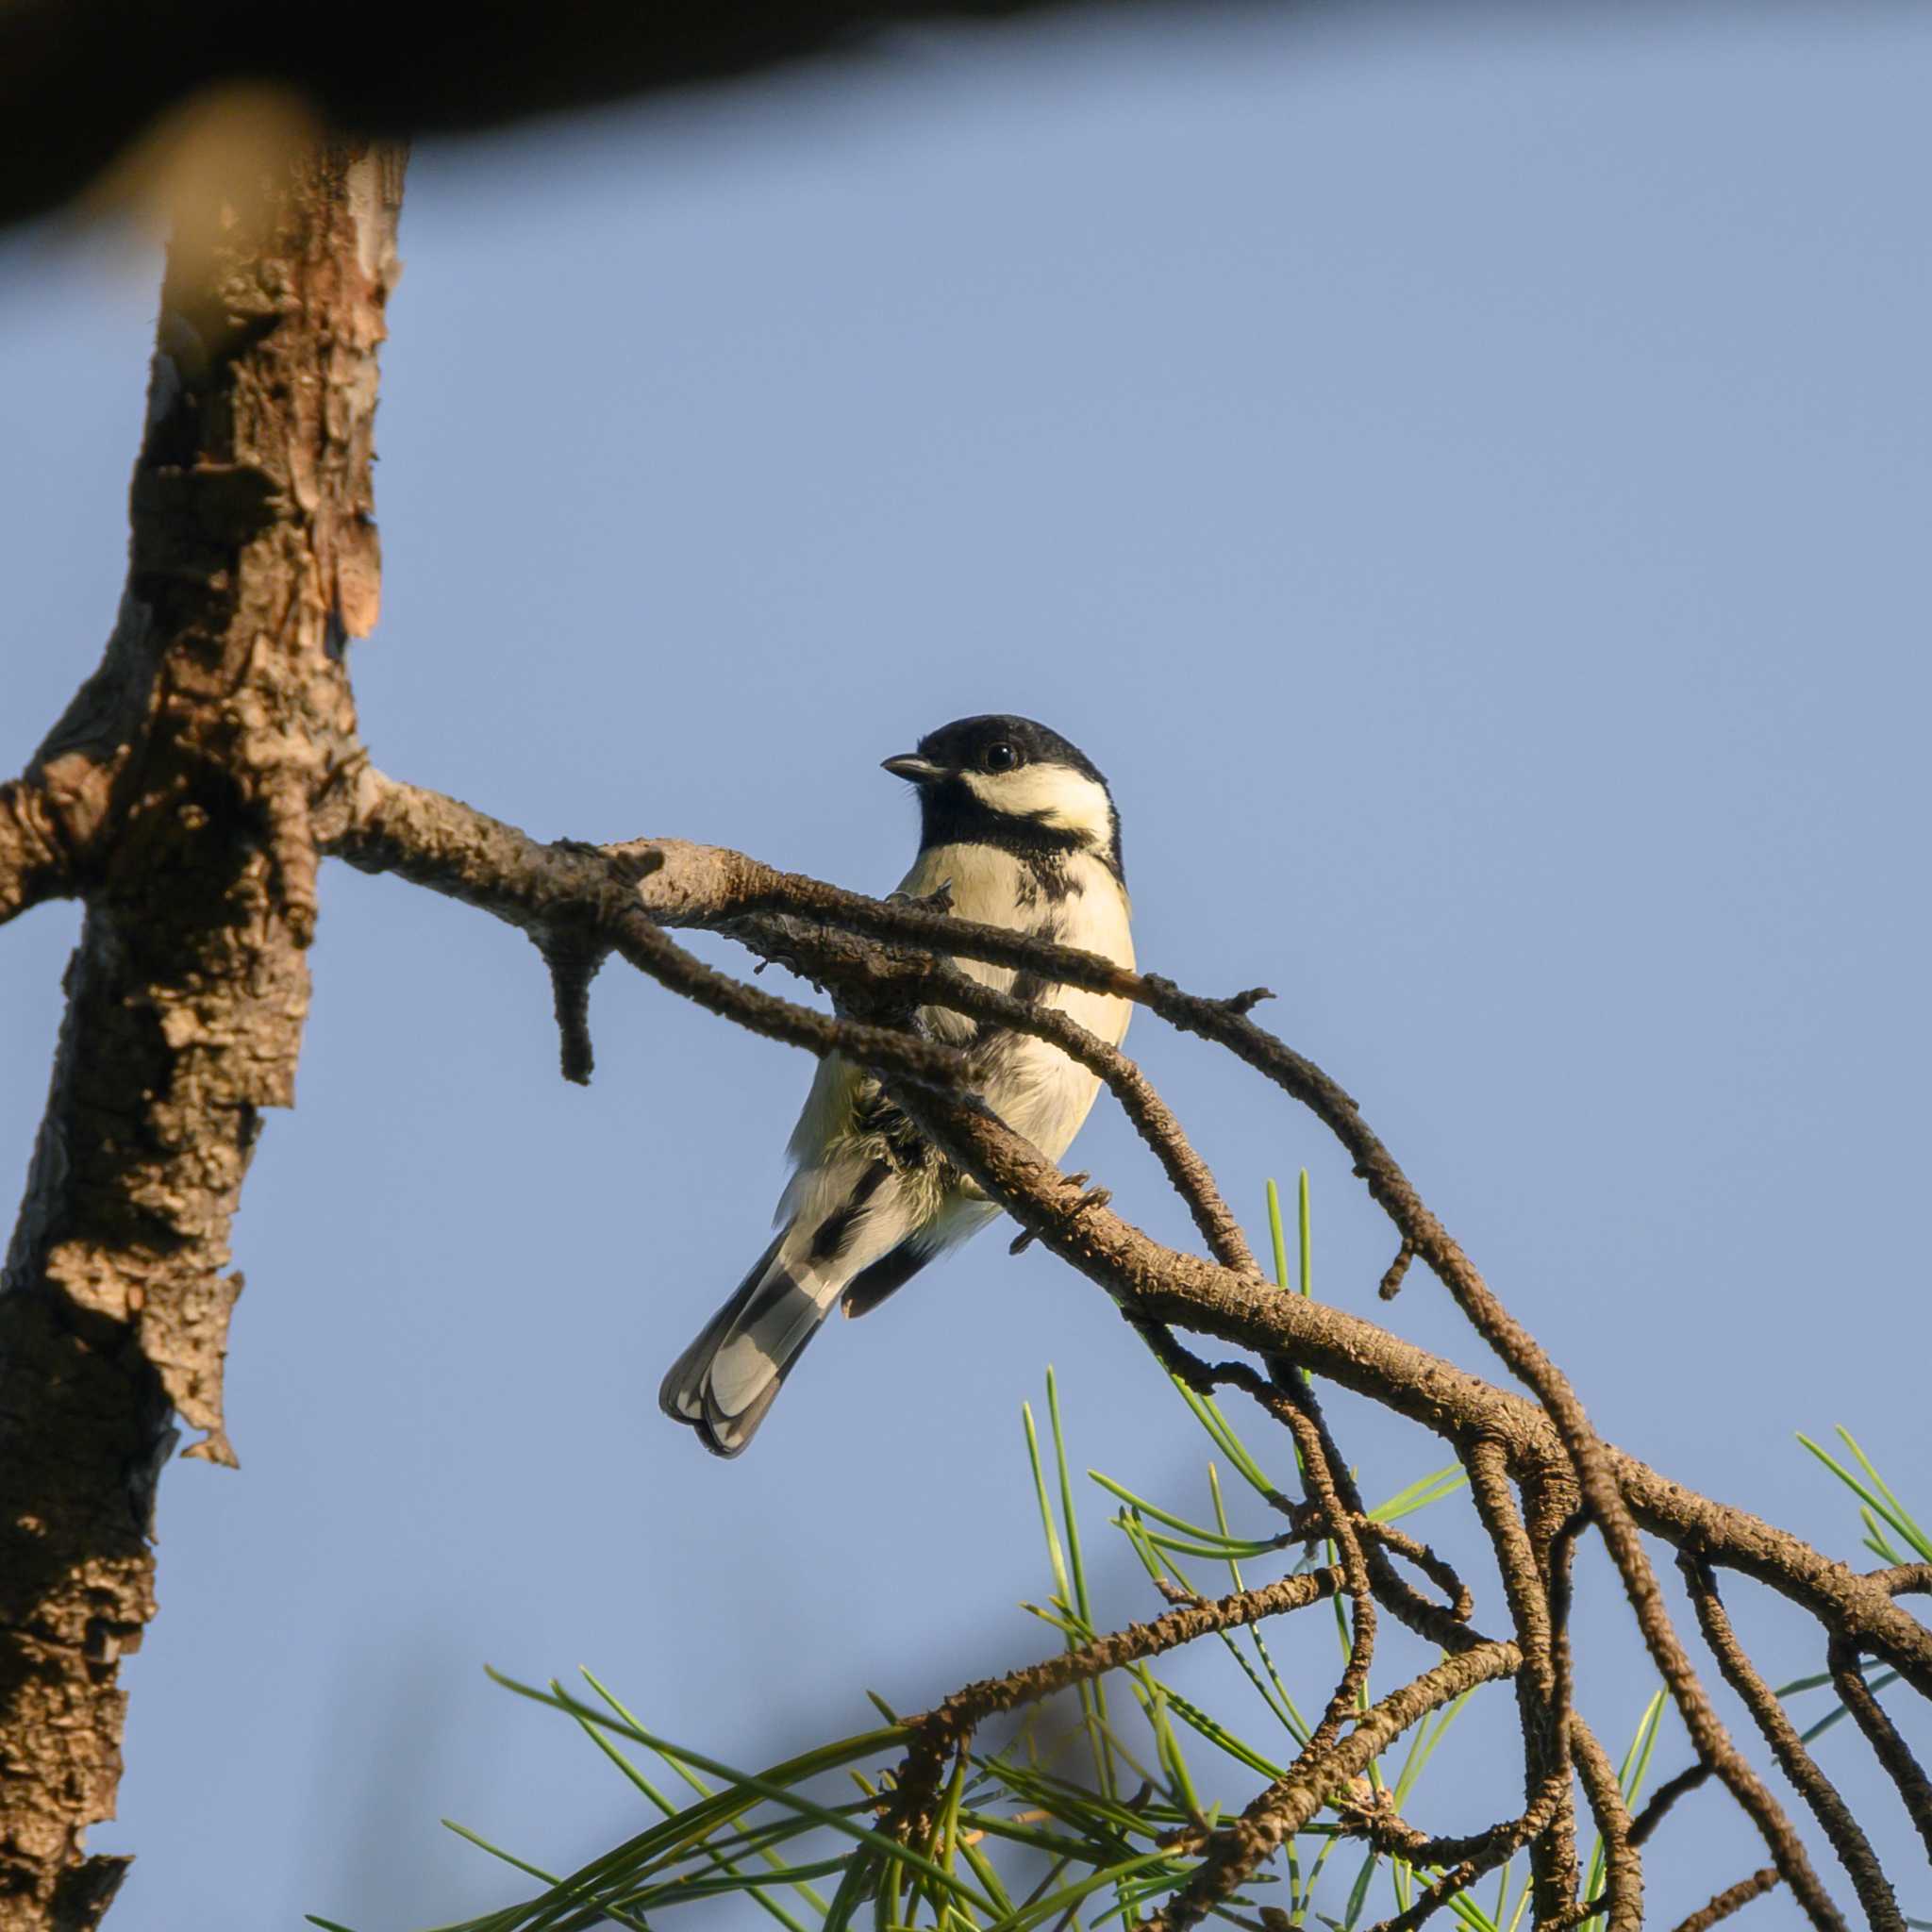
[658,717,1134,1455]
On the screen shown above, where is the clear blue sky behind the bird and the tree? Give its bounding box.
[0,6,1932,1932]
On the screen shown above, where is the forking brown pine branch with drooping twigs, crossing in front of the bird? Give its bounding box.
[320,773,1932,1926]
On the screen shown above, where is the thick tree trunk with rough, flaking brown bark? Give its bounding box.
[0,149,402,1932]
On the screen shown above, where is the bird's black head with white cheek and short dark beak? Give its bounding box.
[885,713,1121,875]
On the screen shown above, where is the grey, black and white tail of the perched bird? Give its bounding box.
[657,1229,842,1457]
